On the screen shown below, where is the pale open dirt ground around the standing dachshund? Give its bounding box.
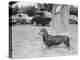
[12,24,78,59]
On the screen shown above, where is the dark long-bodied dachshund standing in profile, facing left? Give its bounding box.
[39,28,70,49]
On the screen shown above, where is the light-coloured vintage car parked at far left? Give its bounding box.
[12,14,32,24]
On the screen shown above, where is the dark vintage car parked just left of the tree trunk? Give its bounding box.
[31,11,52,26]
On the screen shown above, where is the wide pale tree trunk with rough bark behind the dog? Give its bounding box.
[51,5,69,34]
